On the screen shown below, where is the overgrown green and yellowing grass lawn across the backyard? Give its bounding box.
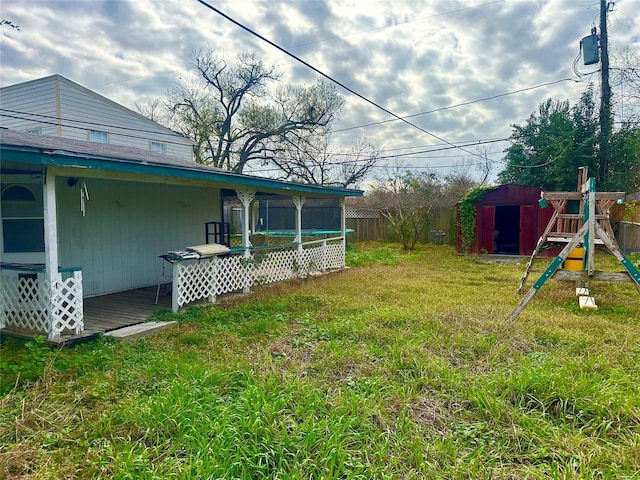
[0,244,640,479]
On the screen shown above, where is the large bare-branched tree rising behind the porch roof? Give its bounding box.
[167,48,368,186]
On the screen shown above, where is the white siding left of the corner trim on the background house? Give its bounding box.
[0,78,59,136]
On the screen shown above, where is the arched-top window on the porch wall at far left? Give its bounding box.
[0,185,44,253]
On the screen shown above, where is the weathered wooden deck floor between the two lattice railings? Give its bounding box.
[1,286,171,345]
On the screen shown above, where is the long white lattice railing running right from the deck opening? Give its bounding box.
[172,237,345,311]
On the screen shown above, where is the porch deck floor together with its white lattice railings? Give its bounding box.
[0,236,345,344]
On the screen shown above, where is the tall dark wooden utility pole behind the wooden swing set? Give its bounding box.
[598,0,613,185]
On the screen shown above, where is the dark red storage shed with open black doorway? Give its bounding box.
[456,184,553,255]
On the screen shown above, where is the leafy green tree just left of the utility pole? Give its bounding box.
[498,87,604,191]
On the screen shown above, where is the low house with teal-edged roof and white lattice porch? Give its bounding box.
[0,82,362,339]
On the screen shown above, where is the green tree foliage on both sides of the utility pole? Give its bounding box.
[498,87,640,192]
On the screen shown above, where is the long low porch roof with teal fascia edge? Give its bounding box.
[0,128,363,196]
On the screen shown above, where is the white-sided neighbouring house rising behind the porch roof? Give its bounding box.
[0,75,193,160]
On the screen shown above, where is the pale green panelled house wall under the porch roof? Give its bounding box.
[56,177,221,296]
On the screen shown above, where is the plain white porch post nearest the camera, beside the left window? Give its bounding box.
[43,169,62,340]
